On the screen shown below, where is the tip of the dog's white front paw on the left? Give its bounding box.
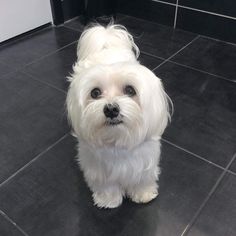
[93,192,123,208]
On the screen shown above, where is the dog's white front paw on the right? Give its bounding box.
[129,186,158,203]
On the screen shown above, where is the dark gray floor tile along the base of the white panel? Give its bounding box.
[0,27,79,69]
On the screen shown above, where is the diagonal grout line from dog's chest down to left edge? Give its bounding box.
[0,132,69,188]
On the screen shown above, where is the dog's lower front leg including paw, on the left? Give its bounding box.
[93,185,123,208]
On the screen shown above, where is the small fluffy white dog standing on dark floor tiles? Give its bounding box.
[67,24,170,208]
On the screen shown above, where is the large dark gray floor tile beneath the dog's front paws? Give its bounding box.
[0,136,221,236]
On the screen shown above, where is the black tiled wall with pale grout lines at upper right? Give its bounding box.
[118,0,236,43]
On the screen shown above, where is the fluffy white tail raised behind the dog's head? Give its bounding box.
[77,24,139,60]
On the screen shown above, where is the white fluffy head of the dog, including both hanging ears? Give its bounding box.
[67,64,169,148]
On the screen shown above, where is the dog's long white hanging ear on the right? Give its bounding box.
[140,66,172,138]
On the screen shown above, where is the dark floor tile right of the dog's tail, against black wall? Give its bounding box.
[119,17,196,58]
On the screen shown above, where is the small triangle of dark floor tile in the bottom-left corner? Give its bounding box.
[0,214,24,236]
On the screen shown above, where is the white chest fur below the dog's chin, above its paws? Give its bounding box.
[78,141,160,187]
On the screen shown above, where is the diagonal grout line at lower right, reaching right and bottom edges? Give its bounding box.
[181,154,236,236]
